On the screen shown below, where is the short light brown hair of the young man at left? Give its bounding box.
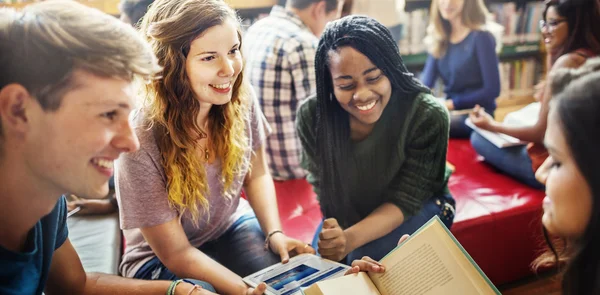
[0,1,160,142]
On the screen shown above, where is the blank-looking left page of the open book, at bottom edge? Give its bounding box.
[304,272,381,295]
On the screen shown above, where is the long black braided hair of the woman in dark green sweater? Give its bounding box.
[315,15,431,227]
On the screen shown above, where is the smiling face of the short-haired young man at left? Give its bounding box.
[22,70,139,198]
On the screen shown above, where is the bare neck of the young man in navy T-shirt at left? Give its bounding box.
[0,156,61,252]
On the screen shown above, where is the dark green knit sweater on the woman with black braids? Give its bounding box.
[296,93,451,224]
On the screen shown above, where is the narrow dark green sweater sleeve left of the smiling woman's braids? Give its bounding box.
[296,96,320,196]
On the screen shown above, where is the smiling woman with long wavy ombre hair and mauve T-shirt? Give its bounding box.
[115,0,314,294]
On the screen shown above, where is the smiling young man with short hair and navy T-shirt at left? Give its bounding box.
[0,1,212,295]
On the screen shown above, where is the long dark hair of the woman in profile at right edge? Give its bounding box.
[534,58,600,295]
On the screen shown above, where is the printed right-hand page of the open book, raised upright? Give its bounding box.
[369,222,496,295]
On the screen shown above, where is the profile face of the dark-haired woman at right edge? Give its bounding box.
[537,108,592,239]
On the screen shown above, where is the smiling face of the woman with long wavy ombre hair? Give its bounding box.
[185,19,243,105]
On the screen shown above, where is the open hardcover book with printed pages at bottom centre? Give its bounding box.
[303,216,500,295]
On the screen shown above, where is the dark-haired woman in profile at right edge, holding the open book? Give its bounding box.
[347,58,600,295]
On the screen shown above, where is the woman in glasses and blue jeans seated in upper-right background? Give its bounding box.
[470,0,600,189]
